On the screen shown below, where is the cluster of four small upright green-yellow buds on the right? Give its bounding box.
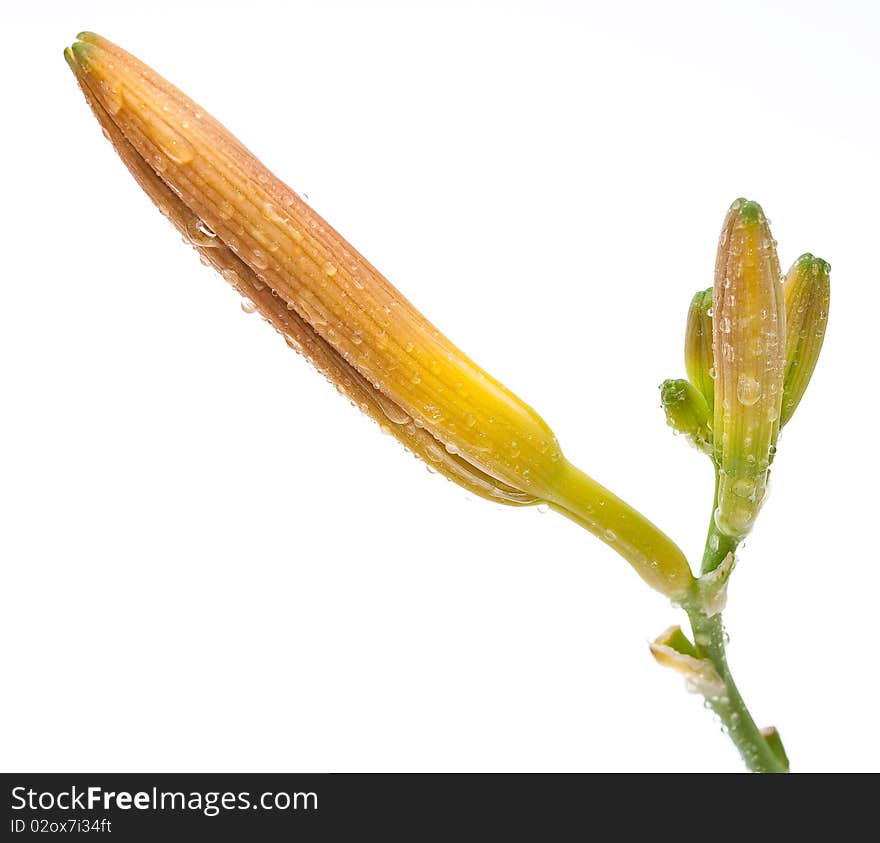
[660,199,830,540]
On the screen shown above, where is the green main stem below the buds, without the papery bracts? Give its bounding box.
[686,473,788,773]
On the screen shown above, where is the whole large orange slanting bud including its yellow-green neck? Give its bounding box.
[65,33,693,598]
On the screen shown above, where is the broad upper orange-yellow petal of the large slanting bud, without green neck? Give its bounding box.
[72,33,562,499]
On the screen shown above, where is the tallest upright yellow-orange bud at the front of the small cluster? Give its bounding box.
[712,199,785,539]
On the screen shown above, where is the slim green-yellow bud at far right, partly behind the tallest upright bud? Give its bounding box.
[780,254,831,425]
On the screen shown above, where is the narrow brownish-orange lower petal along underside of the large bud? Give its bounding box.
[65,47,536,505]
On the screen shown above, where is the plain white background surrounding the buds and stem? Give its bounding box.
[0,0,880,771]
